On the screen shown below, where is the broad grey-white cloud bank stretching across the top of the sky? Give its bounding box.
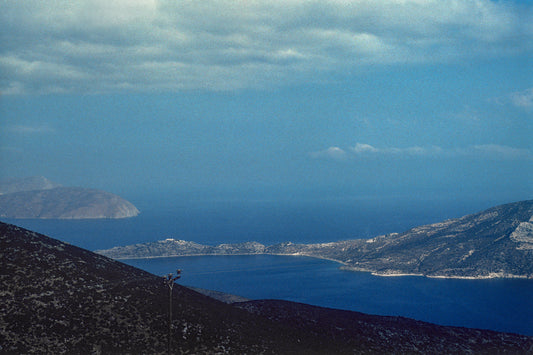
[0,0,532,94]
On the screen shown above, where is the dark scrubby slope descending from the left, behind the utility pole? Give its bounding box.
[0,223,315,353]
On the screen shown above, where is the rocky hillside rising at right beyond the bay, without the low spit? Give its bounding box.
[330,200,533,278]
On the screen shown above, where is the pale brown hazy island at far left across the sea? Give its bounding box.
[0,176,139,219]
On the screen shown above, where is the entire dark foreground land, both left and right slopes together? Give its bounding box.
[0,223,533,354]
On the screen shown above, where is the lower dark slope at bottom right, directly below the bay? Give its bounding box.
[236,300,533,354]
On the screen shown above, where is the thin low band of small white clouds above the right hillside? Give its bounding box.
[310,143,533,161]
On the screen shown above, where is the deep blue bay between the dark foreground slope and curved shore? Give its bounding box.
[123,255,533,335]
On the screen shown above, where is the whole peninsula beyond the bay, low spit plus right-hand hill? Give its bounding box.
[96,200,533,279]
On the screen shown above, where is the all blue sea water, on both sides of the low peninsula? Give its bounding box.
[2,196,533,336]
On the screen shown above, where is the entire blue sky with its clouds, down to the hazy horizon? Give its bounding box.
[0,0,533,203]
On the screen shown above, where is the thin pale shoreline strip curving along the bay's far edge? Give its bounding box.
[99,253,533,280]
